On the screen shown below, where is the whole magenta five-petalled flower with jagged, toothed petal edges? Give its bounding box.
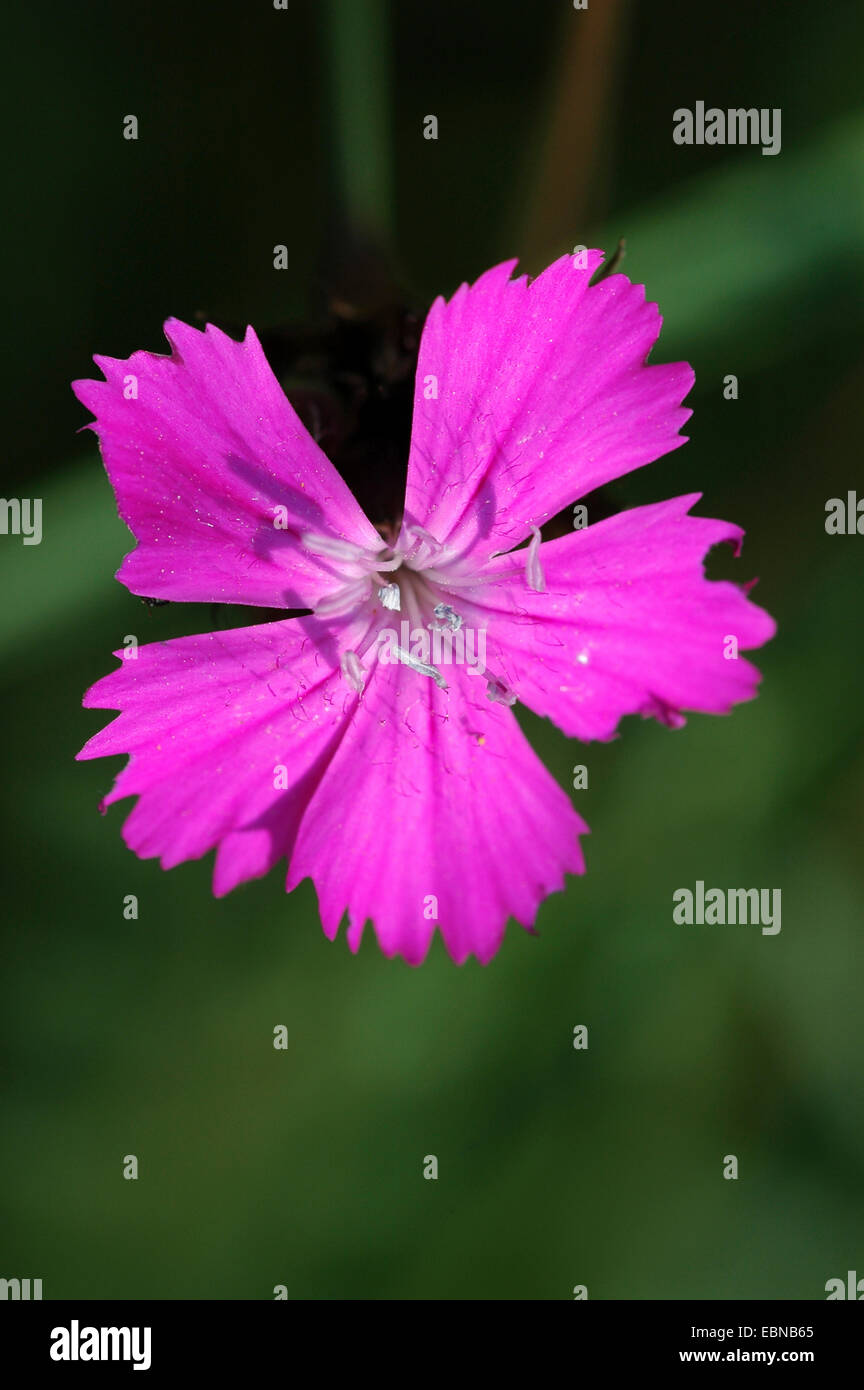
[74,252,774,965]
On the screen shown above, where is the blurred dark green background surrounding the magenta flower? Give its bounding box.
[0,0,864,1300]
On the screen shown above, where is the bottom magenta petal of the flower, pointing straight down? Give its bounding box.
[288,664,588,965]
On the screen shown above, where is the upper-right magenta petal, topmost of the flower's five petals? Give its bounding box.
[406,252,693,559]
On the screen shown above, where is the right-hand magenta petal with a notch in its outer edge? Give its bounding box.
[460,493,775,739]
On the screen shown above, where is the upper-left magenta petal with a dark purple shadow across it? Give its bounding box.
[72,318,381,607]
